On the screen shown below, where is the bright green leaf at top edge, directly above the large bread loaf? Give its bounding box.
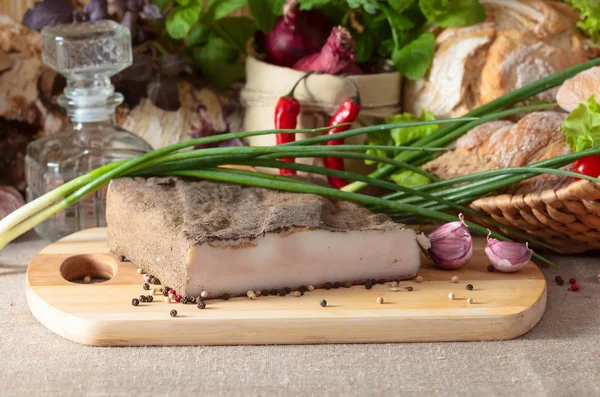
[419,0,485,28]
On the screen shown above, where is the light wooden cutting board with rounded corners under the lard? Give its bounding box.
[27,229,546,346]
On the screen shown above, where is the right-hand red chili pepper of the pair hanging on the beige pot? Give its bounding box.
[323,80,360,189]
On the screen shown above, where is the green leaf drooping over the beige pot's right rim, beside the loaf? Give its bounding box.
[392,32,435,80]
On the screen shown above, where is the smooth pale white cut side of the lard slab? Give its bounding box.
[187,229,420,296]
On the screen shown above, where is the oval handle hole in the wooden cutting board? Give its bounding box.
[60,255,117,284]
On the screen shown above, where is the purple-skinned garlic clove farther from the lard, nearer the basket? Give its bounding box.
[485,235,533,273]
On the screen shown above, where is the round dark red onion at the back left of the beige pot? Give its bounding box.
[265,0,333,67]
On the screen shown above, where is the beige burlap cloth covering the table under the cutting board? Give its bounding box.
[0,230,600,397]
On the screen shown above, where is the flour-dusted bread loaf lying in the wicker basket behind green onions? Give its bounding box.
[424,111,572,194]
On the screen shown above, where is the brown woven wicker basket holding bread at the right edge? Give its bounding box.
[471,180,600,253]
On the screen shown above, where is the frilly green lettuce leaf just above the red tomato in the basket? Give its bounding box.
[562,95,600,152]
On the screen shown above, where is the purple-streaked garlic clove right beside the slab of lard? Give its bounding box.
[423,214,473,269]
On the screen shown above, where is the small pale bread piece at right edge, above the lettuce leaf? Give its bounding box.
[556,66,600,112]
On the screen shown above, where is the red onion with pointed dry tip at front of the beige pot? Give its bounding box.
[294,26,362,74]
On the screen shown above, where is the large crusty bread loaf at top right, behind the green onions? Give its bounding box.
[403,0,597,118]
